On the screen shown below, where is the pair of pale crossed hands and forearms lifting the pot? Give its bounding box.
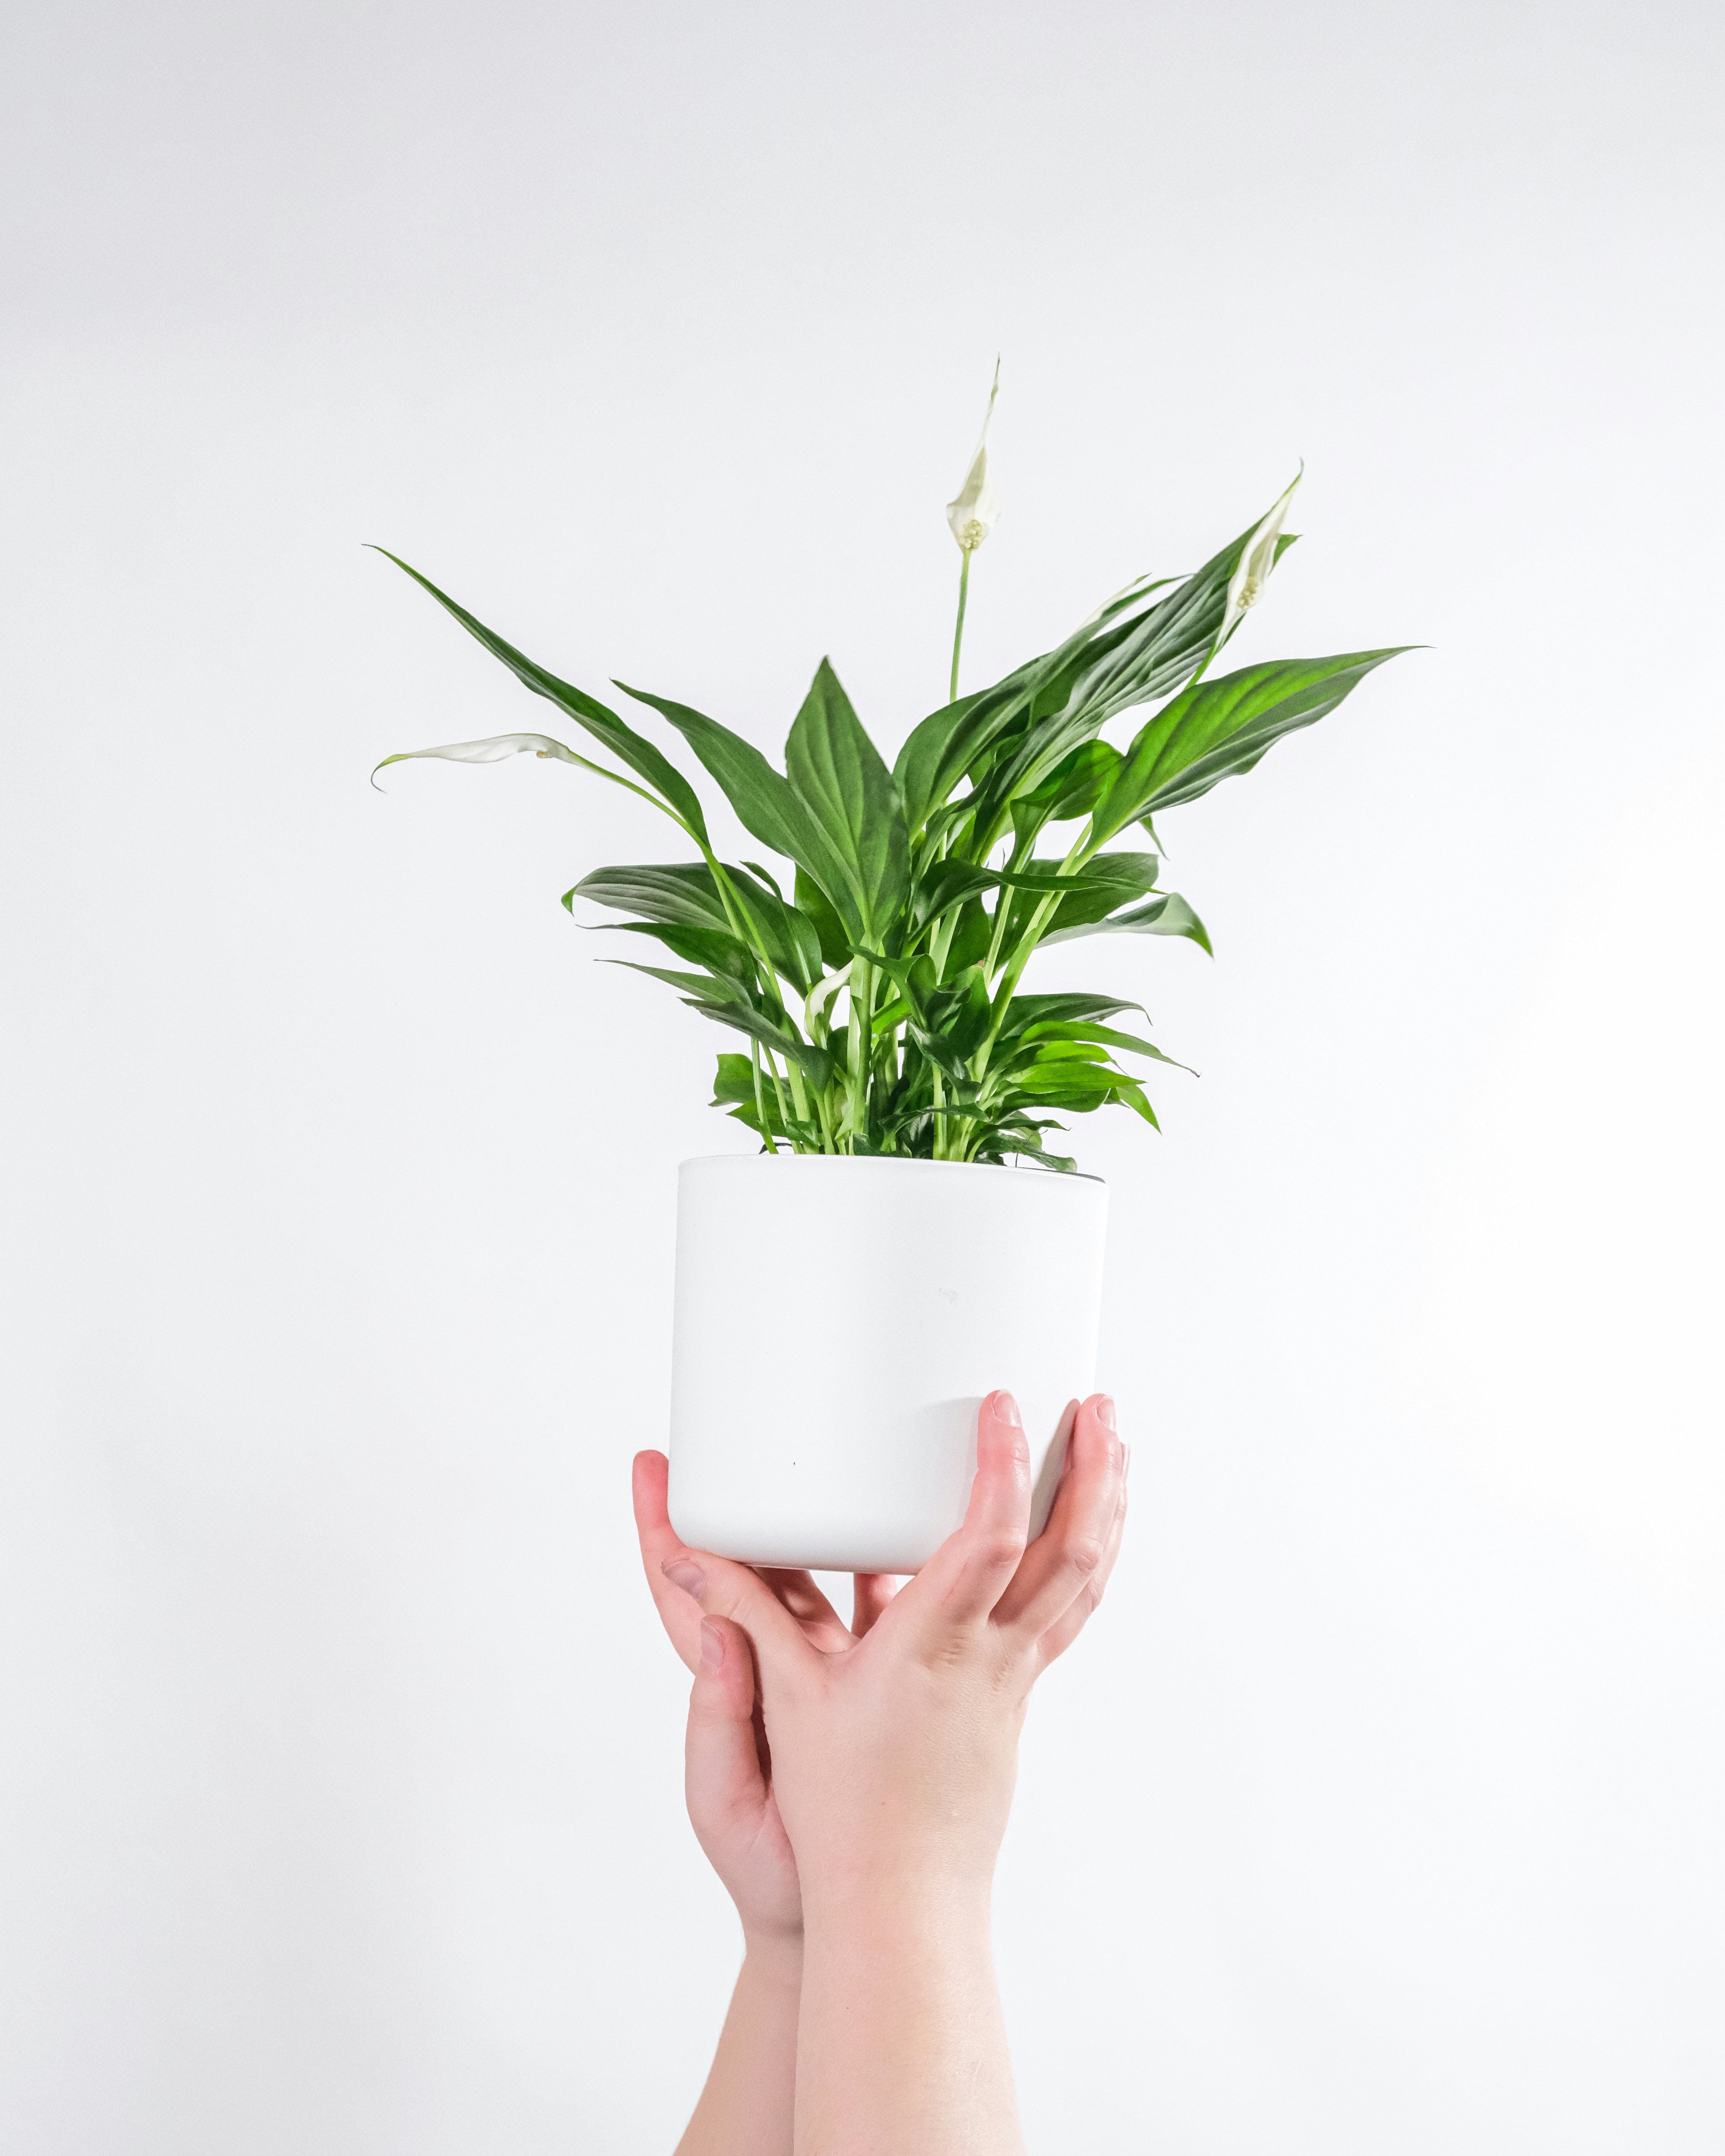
[634,1393,1128,2156]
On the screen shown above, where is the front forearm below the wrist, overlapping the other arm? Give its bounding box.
[796,1884,1024,2156]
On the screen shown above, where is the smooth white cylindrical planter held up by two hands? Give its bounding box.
[671,1153,1108,1572]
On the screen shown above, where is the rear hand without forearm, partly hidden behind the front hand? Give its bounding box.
[634,1453,895,1949]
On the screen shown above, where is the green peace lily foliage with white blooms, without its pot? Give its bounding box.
[373,384,1408,1169]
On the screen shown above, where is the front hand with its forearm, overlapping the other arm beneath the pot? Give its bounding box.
[643,1393,1126,2156]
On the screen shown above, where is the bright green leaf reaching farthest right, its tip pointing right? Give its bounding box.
[1093,645,1410,841]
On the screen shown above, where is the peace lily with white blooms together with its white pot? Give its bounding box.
[373,392,1406,1572]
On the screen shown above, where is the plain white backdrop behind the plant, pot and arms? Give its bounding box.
[0,0,1725,2156]
